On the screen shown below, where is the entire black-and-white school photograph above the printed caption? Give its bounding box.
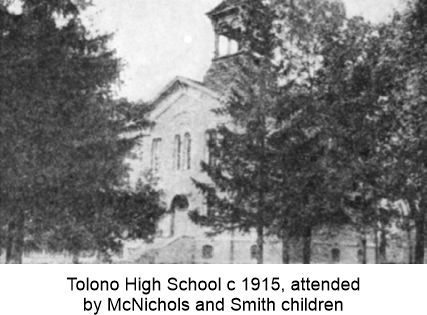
[0,0,427,264]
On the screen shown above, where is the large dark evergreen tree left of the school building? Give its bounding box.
[0,0,164,263]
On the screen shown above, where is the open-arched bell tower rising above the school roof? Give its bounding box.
[203,0,247,93]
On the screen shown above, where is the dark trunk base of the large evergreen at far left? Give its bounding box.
[6,210,25,264]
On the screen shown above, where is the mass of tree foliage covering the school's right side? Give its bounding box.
[194,0,426,262]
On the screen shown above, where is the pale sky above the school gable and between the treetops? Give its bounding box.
[85,0,404,101]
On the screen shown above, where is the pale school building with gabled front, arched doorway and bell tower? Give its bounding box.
[122,0,407,263]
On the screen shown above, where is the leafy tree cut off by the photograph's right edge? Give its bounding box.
[387,0,427,263]
